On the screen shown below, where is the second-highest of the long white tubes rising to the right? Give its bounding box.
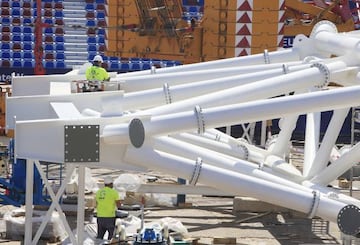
[116,61,305,93]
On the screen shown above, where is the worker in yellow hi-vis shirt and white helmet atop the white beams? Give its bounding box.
[84,55,110,92]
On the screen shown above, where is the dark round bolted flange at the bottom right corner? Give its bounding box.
[337,204,360,236]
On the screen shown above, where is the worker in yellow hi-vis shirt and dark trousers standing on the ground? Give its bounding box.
[96,176,121,240]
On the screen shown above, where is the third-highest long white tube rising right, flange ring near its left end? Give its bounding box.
[123,64,310,110]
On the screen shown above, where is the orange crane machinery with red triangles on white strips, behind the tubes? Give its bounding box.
[104,0,359,64]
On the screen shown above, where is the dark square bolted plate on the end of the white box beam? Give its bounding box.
[64,125,100,163]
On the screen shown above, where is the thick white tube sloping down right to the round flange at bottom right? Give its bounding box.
[124,147,352,223]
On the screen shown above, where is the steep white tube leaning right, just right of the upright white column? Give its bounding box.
[304,108,349,179]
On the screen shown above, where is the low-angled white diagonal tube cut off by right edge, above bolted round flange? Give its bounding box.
[310,143,360,185]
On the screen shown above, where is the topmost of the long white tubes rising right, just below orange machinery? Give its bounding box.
[116,48,301,78]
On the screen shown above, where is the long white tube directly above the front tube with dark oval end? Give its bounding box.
[134,62,346,116]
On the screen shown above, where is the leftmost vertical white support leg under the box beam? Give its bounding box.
[24,159,34,245]
